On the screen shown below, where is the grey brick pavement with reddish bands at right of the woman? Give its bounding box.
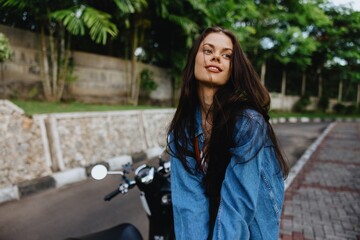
[280,122,360,240]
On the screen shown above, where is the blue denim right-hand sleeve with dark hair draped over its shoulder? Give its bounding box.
[213,112,266,240]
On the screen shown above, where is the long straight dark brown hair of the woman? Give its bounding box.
[168,27,289,228]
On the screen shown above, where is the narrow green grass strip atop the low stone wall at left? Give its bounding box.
[10,99,163,116]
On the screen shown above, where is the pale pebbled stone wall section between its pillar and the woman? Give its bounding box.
[48,109,174,171]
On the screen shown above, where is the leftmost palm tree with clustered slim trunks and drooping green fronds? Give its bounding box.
[0,0,118,101]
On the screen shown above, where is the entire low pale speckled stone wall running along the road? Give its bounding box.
[0,100,174,199]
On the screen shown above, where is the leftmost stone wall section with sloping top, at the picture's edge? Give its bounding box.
[0,100,52,188]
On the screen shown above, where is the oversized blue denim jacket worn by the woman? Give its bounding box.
[169,109,284,240]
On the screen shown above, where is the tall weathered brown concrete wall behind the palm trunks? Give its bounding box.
[0,25,172,103]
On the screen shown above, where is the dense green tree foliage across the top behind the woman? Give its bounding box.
[0,0,360,104]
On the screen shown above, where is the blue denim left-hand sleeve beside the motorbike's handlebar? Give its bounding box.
[170,150,209,240]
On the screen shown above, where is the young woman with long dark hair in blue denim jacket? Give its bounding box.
[168,27,288,240]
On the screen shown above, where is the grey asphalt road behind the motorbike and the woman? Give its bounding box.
[0,123,328,240]
